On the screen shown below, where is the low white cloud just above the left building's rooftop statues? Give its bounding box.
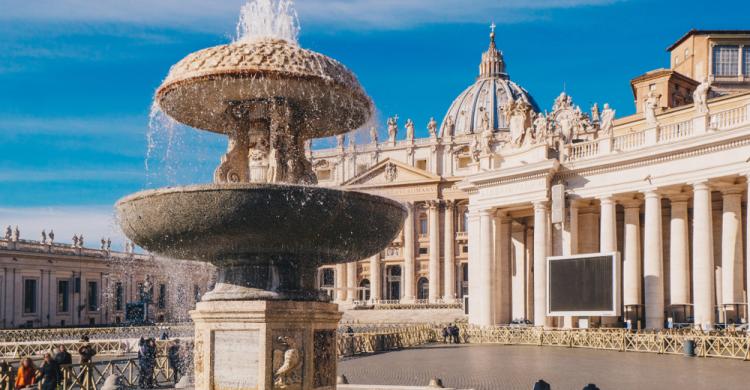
[0,205,125,250]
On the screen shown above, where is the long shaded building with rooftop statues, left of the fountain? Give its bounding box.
[0,227,213,328]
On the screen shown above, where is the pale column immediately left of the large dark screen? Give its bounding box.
[534,201,549,326]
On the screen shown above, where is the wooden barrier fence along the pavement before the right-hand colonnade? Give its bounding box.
[461,326,750,360]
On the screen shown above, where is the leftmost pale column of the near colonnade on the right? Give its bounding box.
[478,210,495,325]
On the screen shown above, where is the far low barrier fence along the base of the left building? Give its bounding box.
[0,323,194,342]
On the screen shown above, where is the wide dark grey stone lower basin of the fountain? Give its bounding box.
[116,184,406,265]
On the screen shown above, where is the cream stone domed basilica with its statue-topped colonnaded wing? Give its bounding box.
[309,30,750,328]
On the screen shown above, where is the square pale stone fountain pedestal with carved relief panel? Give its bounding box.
[190,300,341,390]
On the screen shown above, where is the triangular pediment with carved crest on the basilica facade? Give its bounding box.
[343,158,441,188]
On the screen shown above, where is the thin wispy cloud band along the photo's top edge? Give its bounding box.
[0,0,620,32]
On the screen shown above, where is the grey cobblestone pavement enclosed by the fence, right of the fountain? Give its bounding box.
[338,344,750,390]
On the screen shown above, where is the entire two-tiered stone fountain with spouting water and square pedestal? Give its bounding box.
[116,0,405,390]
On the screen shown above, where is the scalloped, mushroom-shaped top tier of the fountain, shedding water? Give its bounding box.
[156,38,373,139]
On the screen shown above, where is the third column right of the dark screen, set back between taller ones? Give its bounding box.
[669,194,690,305]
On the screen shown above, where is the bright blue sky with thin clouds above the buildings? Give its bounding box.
[0,0,750,248]
